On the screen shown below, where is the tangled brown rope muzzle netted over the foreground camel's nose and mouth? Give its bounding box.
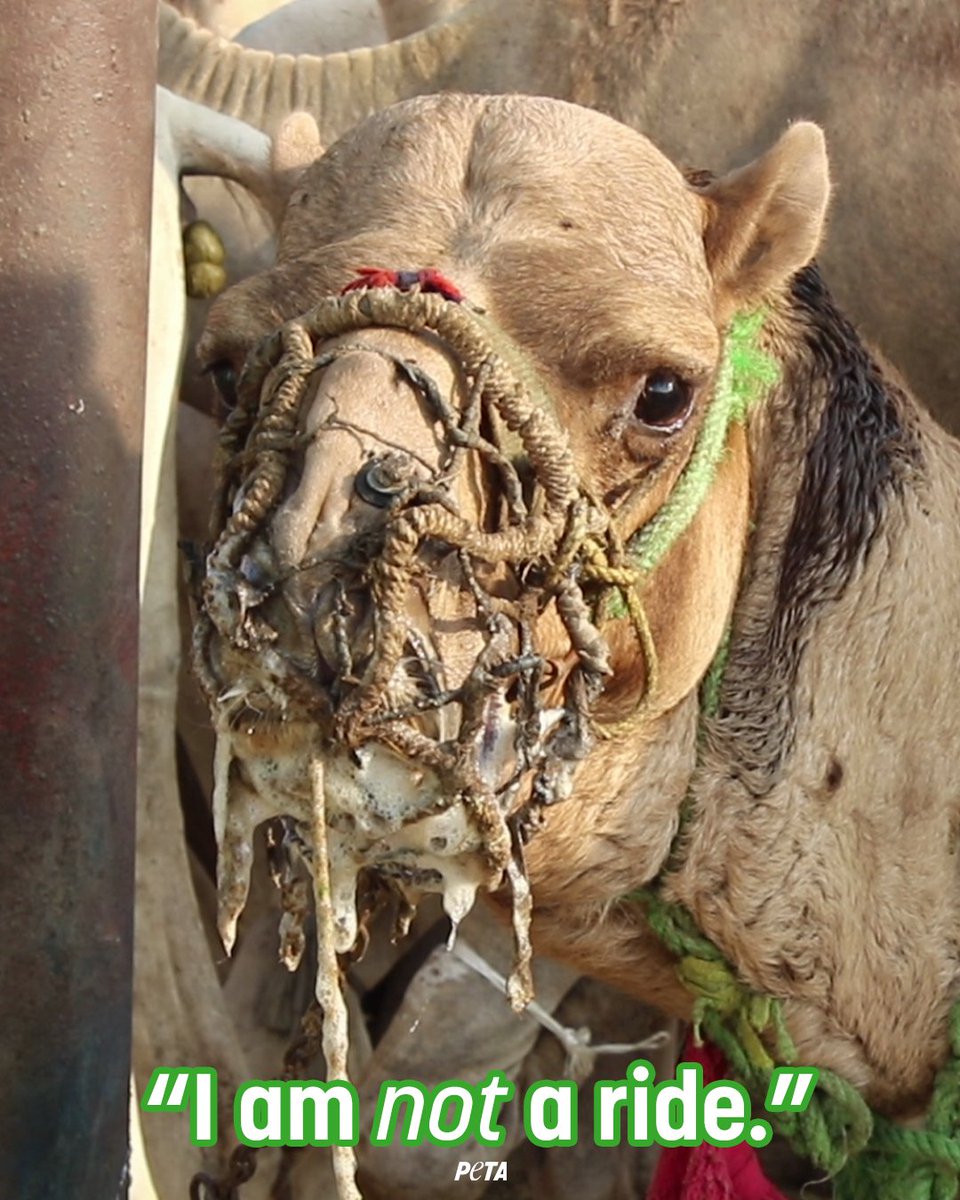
[196,288,655,1022]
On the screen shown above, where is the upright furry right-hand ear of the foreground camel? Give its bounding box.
[703,121,830,306]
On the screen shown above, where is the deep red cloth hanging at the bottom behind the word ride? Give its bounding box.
[647,1034,786,1200]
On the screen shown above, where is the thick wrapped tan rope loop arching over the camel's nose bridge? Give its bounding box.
[206,288,658,736]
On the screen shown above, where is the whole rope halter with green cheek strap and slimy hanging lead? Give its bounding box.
[194,280,796,1195]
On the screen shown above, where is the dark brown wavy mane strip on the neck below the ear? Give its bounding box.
[713,268,923,796]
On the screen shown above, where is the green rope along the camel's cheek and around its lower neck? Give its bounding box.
[624,311,960,1200]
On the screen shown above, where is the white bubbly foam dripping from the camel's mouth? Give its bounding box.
[214,697,563,968]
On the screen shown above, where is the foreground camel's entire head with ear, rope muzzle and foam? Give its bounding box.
[196,96,828,1003]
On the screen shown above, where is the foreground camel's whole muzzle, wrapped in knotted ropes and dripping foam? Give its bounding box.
[194,288,638,1006]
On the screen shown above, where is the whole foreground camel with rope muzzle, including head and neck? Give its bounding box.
[190,95,960,1190]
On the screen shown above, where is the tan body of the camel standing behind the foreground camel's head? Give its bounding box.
[158,0,960,441]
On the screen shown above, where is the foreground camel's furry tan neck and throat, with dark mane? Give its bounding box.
[532,270,960,1112]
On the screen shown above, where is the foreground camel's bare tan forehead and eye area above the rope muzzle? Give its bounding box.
[203,97,720,561]
